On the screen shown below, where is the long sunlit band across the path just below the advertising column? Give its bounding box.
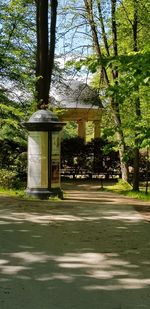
[0,204,143,228]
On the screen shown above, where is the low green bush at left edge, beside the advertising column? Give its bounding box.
[0,169,20,189]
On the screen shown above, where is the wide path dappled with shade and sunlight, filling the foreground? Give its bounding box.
[0,184,150,309]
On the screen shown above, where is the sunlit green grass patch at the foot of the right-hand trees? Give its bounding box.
[104,179,150,201]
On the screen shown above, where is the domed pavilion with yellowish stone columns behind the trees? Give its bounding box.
[51,80,103,140]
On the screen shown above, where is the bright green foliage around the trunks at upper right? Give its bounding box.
[62,0,150,161]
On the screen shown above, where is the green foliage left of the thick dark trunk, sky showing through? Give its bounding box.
[0,0,35,153]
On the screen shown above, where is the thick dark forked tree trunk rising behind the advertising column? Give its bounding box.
[36,0,58,109]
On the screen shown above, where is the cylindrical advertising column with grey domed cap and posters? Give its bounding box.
[24,109,65,199]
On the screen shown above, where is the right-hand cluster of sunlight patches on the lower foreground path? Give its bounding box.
[56,252,150,290]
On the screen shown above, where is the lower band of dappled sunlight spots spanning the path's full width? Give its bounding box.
[0,251,150,291]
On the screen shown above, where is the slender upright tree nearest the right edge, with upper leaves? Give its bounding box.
[118,0,149,191]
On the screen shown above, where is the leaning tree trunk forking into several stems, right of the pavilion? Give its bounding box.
[84,0,128,181]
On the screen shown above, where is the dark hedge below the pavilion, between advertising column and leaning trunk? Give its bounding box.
[61,137,120,177]
